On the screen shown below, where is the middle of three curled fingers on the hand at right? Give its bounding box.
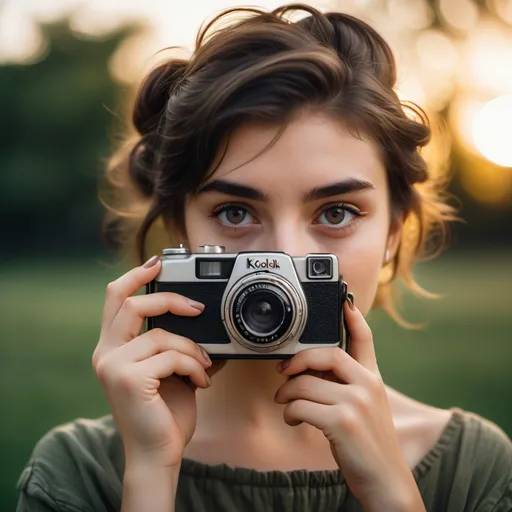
[274,375,346,405]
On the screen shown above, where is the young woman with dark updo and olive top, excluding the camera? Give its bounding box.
[18,5,512,512]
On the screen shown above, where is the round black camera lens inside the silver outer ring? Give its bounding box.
[233,282,293,344]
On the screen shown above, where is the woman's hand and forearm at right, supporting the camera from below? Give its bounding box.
[274,301,425,511]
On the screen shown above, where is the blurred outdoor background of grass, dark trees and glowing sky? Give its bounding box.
[0,0,512,510]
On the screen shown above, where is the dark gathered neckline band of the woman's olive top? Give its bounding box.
[181,407,464,487]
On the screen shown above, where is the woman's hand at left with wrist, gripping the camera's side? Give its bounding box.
[92,256,220,467]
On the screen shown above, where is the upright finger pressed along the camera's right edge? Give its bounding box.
[343,300,378,372]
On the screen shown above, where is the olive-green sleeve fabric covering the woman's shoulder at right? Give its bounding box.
[415,408,512,512]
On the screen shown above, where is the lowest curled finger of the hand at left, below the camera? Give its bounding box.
[136,350,211,388]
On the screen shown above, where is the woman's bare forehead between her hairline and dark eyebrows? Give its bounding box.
[211,115,386,193]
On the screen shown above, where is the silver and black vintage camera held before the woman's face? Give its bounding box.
[146,245,349,359]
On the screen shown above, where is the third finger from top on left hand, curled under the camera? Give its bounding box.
[116,329,212,369]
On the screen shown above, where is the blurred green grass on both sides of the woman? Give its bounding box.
[0,254,512,510]
